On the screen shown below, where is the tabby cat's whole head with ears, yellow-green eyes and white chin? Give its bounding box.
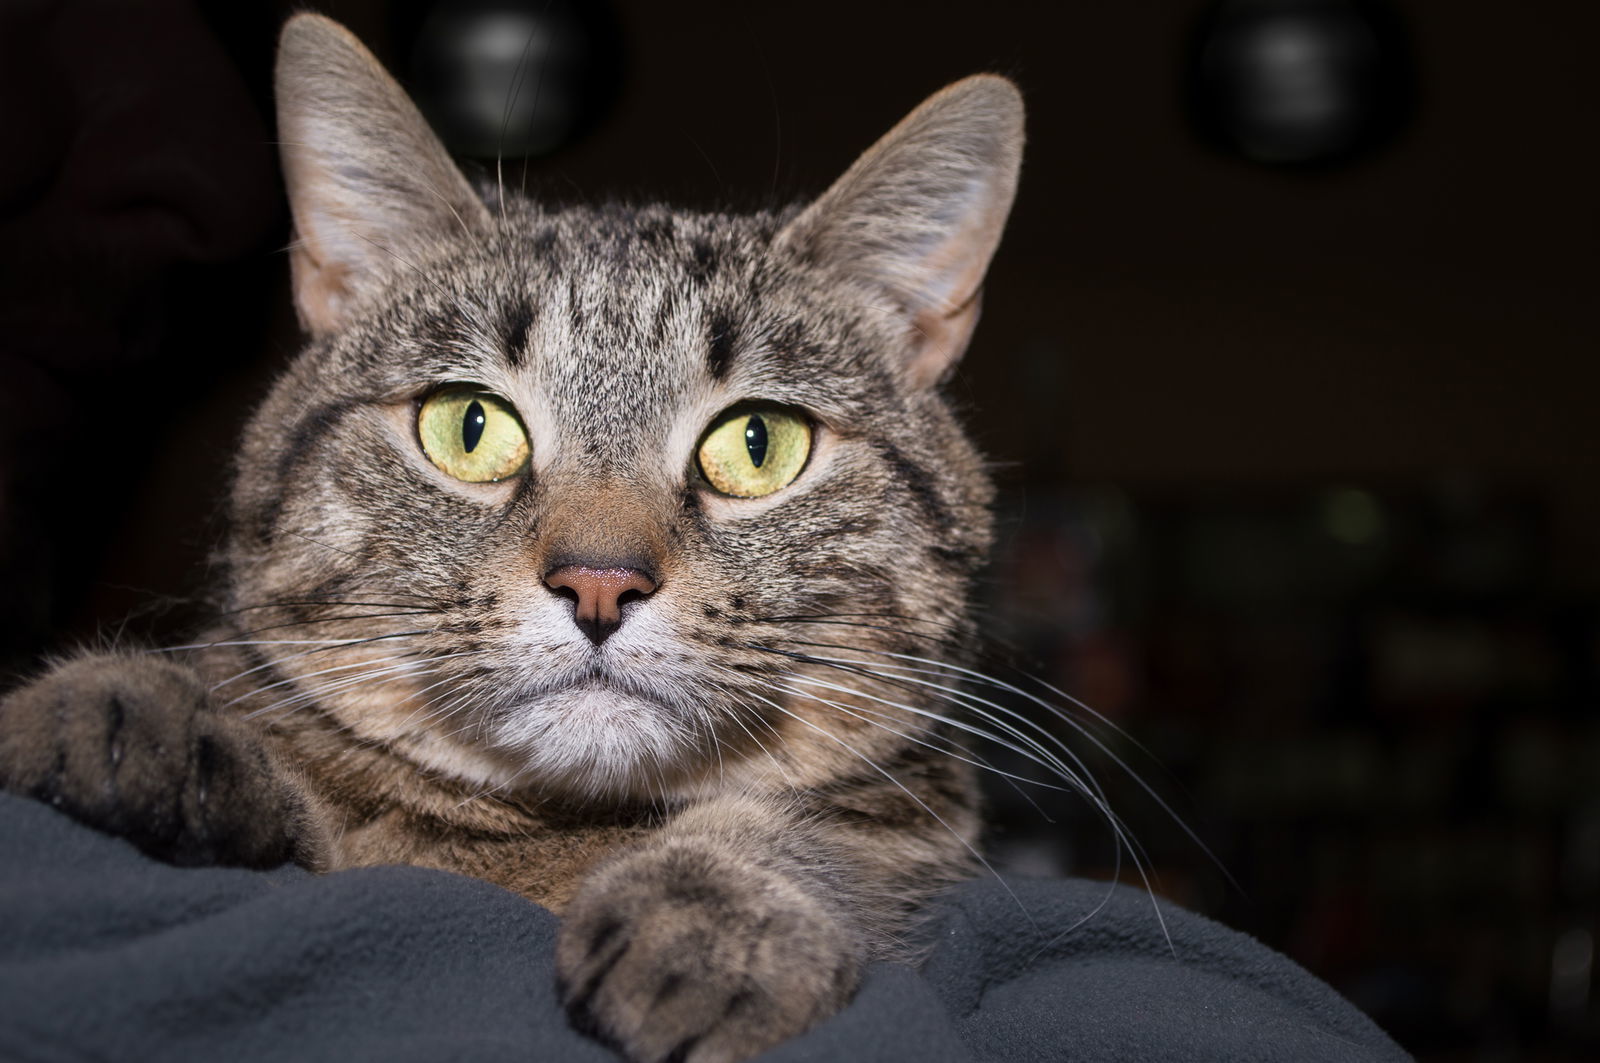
[226,16,1022,794]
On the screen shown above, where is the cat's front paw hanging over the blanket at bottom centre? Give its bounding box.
[555,839,861,1063]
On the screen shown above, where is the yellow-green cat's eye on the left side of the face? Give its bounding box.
[416,384,528,483]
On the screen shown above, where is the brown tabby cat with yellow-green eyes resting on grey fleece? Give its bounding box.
[0,14,1022,1063]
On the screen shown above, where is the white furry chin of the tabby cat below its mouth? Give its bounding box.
[485,679,704,797]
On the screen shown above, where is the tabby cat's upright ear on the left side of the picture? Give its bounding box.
[275,14,491,336]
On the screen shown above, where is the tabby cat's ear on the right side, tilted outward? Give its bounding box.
[778,74,1022,387]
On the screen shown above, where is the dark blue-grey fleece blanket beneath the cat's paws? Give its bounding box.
[0,794,1406,1063]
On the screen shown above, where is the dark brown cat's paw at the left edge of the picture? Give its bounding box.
[0,655,310,868]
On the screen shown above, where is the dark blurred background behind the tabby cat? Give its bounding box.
[0,0,1600,1060]
